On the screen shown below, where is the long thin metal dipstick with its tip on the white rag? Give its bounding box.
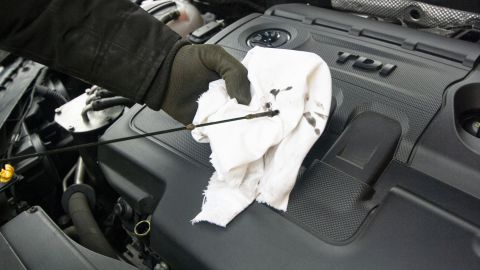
[0,110,280,164]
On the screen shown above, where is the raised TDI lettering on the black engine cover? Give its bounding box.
[337,52,397,76]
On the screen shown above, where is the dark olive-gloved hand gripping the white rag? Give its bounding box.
[161,44,251,124]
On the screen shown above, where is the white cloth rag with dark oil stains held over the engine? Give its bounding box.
[192,47,332,227]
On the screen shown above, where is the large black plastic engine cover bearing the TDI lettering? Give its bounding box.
[99,4,480,269]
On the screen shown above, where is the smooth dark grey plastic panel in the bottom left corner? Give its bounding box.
[0,206,136,270]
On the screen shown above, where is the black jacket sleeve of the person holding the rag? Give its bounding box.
[0,0,185,109]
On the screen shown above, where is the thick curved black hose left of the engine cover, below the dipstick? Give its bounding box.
[68,192,117,259]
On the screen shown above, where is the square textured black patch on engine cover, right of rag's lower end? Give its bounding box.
[286,161,372,243]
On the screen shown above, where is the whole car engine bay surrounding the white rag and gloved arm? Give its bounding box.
[0,1,480,270]
